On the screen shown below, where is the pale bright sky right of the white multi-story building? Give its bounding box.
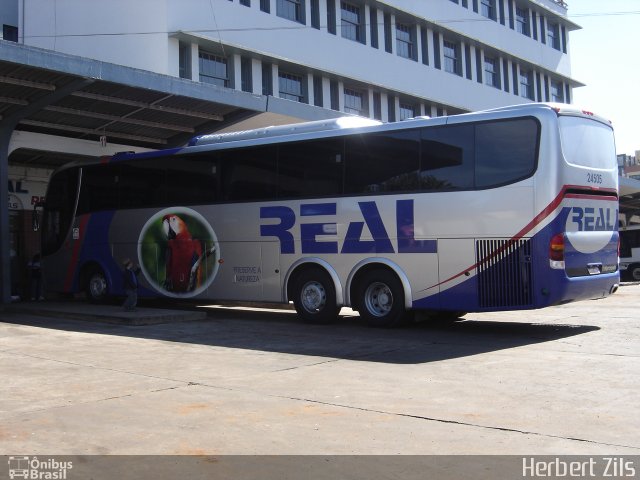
[567,0,640,155]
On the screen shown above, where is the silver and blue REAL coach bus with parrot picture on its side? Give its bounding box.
[42,104,619,326]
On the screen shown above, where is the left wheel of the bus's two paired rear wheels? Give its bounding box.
[293,268,340,323]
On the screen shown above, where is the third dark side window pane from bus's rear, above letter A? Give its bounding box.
[345,130,420,193]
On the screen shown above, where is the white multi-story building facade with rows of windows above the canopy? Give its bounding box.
[16,0,581,121]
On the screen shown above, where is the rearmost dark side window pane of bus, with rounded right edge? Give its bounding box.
[476,119,538,188]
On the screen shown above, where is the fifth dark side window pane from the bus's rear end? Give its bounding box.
[220,145,277,201]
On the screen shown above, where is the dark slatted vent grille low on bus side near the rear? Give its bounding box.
[476,239,533,308]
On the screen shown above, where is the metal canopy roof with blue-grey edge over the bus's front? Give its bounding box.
[0,41,340,159]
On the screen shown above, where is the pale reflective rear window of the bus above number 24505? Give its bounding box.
[560,116,617,169]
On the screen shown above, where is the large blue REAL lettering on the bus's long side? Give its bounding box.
[260,200,437,254]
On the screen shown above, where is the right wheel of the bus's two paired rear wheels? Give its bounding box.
[355,268,406,328]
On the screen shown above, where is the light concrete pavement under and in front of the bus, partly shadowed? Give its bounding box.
[0,285,640,455]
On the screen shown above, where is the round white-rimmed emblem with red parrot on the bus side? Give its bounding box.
[138,207,220,298]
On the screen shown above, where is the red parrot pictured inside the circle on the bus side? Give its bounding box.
[162,214,215,293]
